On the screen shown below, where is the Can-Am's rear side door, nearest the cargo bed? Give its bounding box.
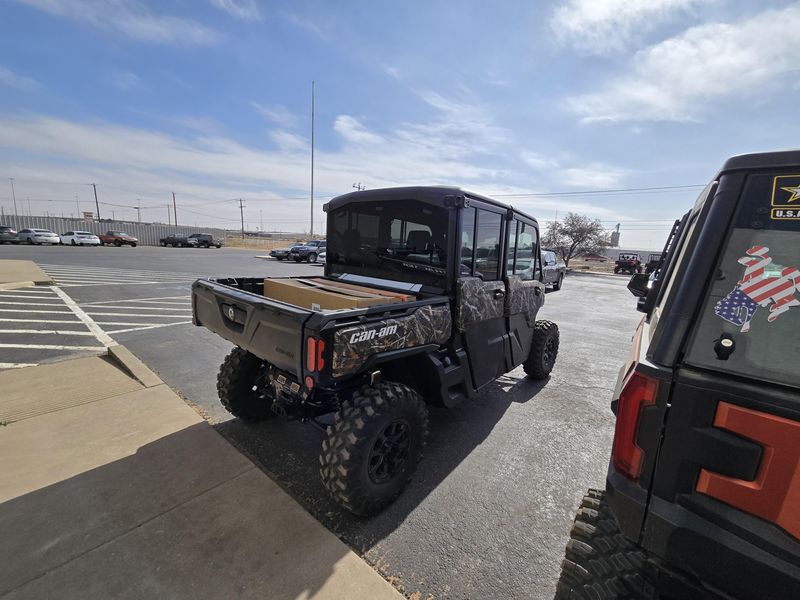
[455,199,508,389]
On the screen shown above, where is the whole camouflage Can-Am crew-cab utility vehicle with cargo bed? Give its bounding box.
[192,187,559,514]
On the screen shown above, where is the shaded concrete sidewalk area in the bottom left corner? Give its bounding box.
[0,423,368,600]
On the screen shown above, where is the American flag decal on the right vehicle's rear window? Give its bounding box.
[714,246,800,332]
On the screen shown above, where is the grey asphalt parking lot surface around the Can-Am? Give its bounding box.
[0,246,640,599]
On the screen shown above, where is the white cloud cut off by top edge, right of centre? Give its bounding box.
[550,0,702,54]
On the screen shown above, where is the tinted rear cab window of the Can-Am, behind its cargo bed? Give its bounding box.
[327,200,448,288]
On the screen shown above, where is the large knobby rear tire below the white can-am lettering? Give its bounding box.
[319,381,428,516]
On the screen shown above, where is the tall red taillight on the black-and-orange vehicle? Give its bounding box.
[611,371,658,481]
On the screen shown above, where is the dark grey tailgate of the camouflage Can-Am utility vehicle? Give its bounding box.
[192,278,313,376]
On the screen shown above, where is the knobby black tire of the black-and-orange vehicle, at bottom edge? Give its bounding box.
[555,490,658,600]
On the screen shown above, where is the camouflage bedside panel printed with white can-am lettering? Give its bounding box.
[332,304,452,377]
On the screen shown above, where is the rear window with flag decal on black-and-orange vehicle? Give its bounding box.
[687,174,800,387]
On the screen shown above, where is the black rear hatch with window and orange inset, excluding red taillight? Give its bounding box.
[640,169,800,599]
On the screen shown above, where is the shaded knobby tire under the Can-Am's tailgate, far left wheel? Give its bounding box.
[217,346,275,423]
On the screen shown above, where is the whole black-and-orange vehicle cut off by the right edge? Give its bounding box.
[556,151,800,600]
